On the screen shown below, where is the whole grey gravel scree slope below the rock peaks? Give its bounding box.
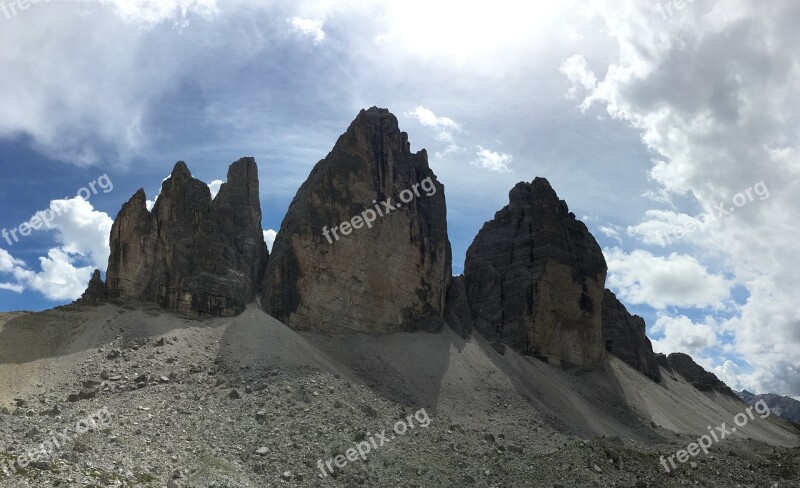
[0,305,800,488]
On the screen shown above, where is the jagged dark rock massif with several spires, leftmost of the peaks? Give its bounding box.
[106,158,268,316]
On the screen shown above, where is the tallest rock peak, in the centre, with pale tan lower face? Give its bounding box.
[262,107,451,333]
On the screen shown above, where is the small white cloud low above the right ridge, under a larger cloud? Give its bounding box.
[651,312,718,358]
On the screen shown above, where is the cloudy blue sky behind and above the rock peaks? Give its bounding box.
[0,0,800,396]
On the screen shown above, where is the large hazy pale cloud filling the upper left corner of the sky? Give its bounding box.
[0,0,222,166]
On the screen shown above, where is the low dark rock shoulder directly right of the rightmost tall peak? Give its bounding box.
[603,290,661,383]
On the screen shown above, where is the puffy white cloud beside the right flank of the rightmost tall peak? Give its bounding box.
[603,247,733,310]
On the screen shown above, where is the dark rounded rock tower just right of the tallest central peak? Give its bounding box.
[464,178,607,366]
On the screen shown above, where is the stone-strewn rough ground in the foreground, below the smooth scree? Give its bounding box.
[0,333,800,488]
